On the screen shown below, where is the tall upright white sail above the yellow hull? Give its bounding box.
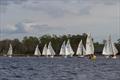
[85,34,94,55]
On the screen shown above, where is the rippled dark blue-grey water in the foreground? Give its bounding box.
[0,57,120,80]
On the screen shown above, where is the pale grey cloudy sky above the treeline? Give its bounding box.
[0,0,120,41]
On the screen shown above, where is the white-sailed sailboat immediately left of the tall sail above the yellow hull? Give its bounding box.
[76,40,86,57]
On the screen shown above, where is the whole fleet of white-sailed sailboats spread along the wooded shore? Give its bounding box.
[4,34,118,59]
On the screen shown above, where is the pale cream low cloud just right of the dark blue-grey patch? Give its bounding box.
[24,22,63,33]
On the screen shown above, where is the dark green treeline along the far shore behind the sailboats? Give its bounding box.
[0,33,120,55]
